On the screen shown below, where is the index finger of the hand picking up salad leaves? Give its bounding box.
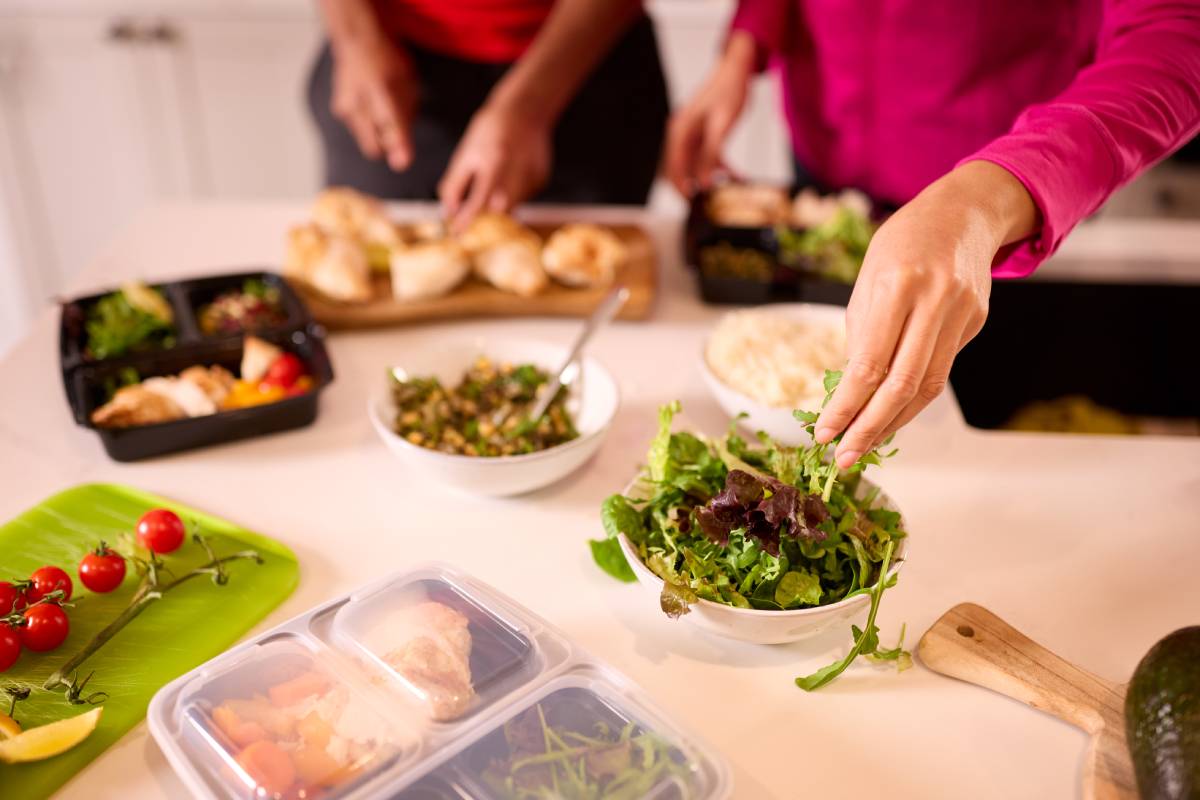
[815,281,911,444]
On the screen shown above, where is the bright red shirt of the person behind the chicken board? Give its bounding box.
[374,0,554,64]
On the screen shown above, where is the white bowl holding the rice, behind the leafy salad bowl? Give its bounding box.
[700,302,846,445]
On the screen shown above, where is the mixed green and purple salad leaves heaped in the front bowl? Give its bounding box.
[590,372,908,690]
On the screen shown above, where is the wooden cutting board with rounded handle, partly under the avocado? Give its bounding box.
[917,603,1138,800]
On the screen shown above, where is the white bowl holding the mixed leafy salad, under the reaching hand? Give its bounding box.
[619,479,910,644]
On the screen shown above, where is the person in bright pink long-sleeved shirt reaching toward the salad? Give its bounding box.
[665,0,1200,467]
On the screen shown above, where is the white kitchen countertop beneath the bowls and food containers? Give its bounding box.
[0,204,1200,800]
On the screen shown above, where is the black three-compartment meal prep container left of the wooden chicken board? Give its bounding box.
[59,271,334,462]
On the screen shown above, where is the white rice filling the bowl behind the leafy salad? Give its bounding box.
[704,308,846,410]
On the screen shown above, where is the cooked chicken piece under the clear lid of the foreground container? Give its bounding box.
[384,601,475,721]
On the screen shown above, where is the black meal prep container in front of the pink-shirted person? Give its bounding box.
[684,192,853,306]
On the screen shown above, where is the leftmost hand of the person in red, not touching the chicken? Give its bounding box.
[330,32,418,172]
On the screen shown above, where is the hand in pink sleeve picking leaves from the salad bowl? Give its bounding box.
[816,161,1037,469]
